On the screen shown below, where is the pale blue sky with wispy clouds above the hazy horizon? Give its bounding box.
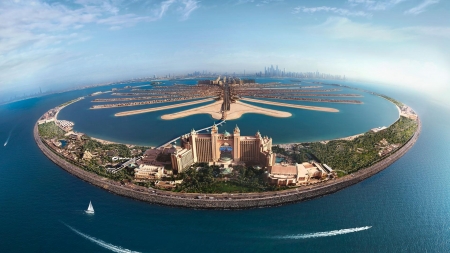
[0,0,450,101]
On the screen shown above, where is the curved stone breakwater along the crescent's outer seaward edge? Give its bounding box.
[33,116,421,209]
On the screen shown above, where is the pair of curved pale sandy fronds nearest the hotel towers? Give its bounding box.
[161,101,292,120]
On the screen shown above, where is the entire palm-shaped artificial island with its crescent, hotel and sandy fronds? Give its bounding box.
[34,76,421,209]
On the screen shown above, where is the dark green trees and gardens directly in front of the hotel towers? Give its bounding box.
[175,163,278,193]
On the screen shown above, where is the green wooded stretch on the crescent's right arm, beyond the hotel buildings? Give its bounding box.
[273,117,418,176]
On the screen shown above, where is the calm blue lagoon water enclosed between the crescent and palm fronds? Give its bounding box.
[58,79,398,146]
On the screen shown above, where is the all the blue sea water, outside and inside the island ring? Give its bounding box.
[0,79,450,252]
